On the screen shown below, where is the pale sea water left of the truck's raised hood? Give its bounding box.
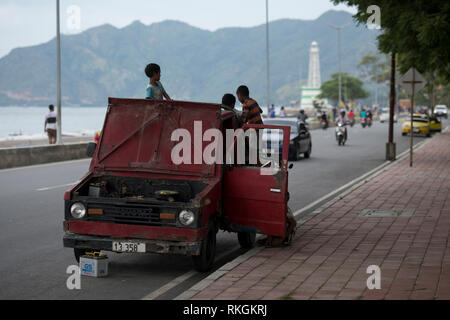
[0,106,107,141]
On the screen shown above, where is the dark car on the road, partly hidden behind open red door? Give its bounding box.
[263,118,312,160]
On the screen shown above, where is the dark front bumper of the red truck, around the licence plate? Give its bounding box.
[63,232,201,256]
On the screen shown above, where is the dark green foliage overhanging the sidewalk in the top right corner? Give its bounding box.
[332,0,450,82]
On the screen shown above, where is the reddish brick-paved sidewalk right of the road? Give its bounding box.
[192,132,450,300]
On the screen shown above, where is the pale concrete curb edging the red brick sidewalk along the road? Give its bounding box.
[174,126,442,300]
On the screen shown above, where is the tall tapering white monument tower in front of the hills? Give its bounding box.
[301,41,321,110]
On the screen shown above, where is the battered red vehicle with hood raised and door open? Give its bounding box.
[63,98,296,271]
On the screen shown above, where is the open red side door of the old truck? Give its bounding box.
[223,125,290,238]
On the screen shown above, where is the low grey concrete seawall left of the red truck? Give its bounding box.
[0,143,87,169]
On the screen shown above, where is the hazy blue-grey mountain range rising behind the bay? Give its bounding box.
[0,11,376,105]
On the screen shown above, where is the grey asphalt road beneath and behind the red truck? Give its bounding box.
[0,118,442,299]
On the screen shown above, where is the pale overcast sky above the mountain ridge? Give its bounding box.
[0,0,356,57]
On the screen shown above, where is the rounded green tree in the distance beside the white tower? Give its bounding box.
[318,73,369,103]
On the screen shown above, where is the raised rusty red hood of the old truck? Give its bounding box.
[90,98,221,176]
